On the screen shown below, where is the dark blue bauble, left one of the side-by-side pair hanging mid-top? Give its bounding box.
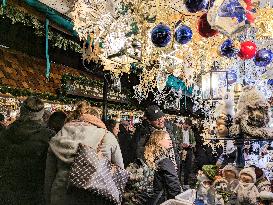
[151,24,172,47]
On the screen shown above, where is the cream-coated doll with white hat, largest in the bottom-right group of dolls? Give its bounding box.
[234,167,259,205]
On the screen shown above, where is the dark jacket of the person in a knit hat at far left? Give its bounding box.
[0,119,54,205]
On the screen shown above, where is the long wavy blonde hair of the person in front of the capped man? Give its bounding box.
[144,130,169,169]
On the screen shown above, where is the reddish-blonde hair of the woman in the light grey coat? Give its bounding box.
[69,100,100,121]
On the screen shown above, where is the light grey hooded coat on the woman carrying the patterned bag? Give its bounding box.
[45,122,124,205]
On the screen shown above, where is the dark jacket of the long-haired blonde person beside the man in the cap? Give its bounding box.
[147,158,181,205]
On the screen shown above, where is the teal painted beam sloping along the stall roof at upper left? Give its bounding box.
[23,0,78,36]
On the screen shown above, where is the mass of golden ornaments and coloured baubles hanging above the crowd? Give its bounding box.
[67,0,273,101]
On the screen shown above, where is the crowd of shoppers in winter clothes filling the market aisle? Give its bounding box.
[0,97,210,205]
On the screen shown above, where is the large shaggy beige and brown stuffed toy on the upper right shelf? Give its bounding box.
[231,86,273,139]
